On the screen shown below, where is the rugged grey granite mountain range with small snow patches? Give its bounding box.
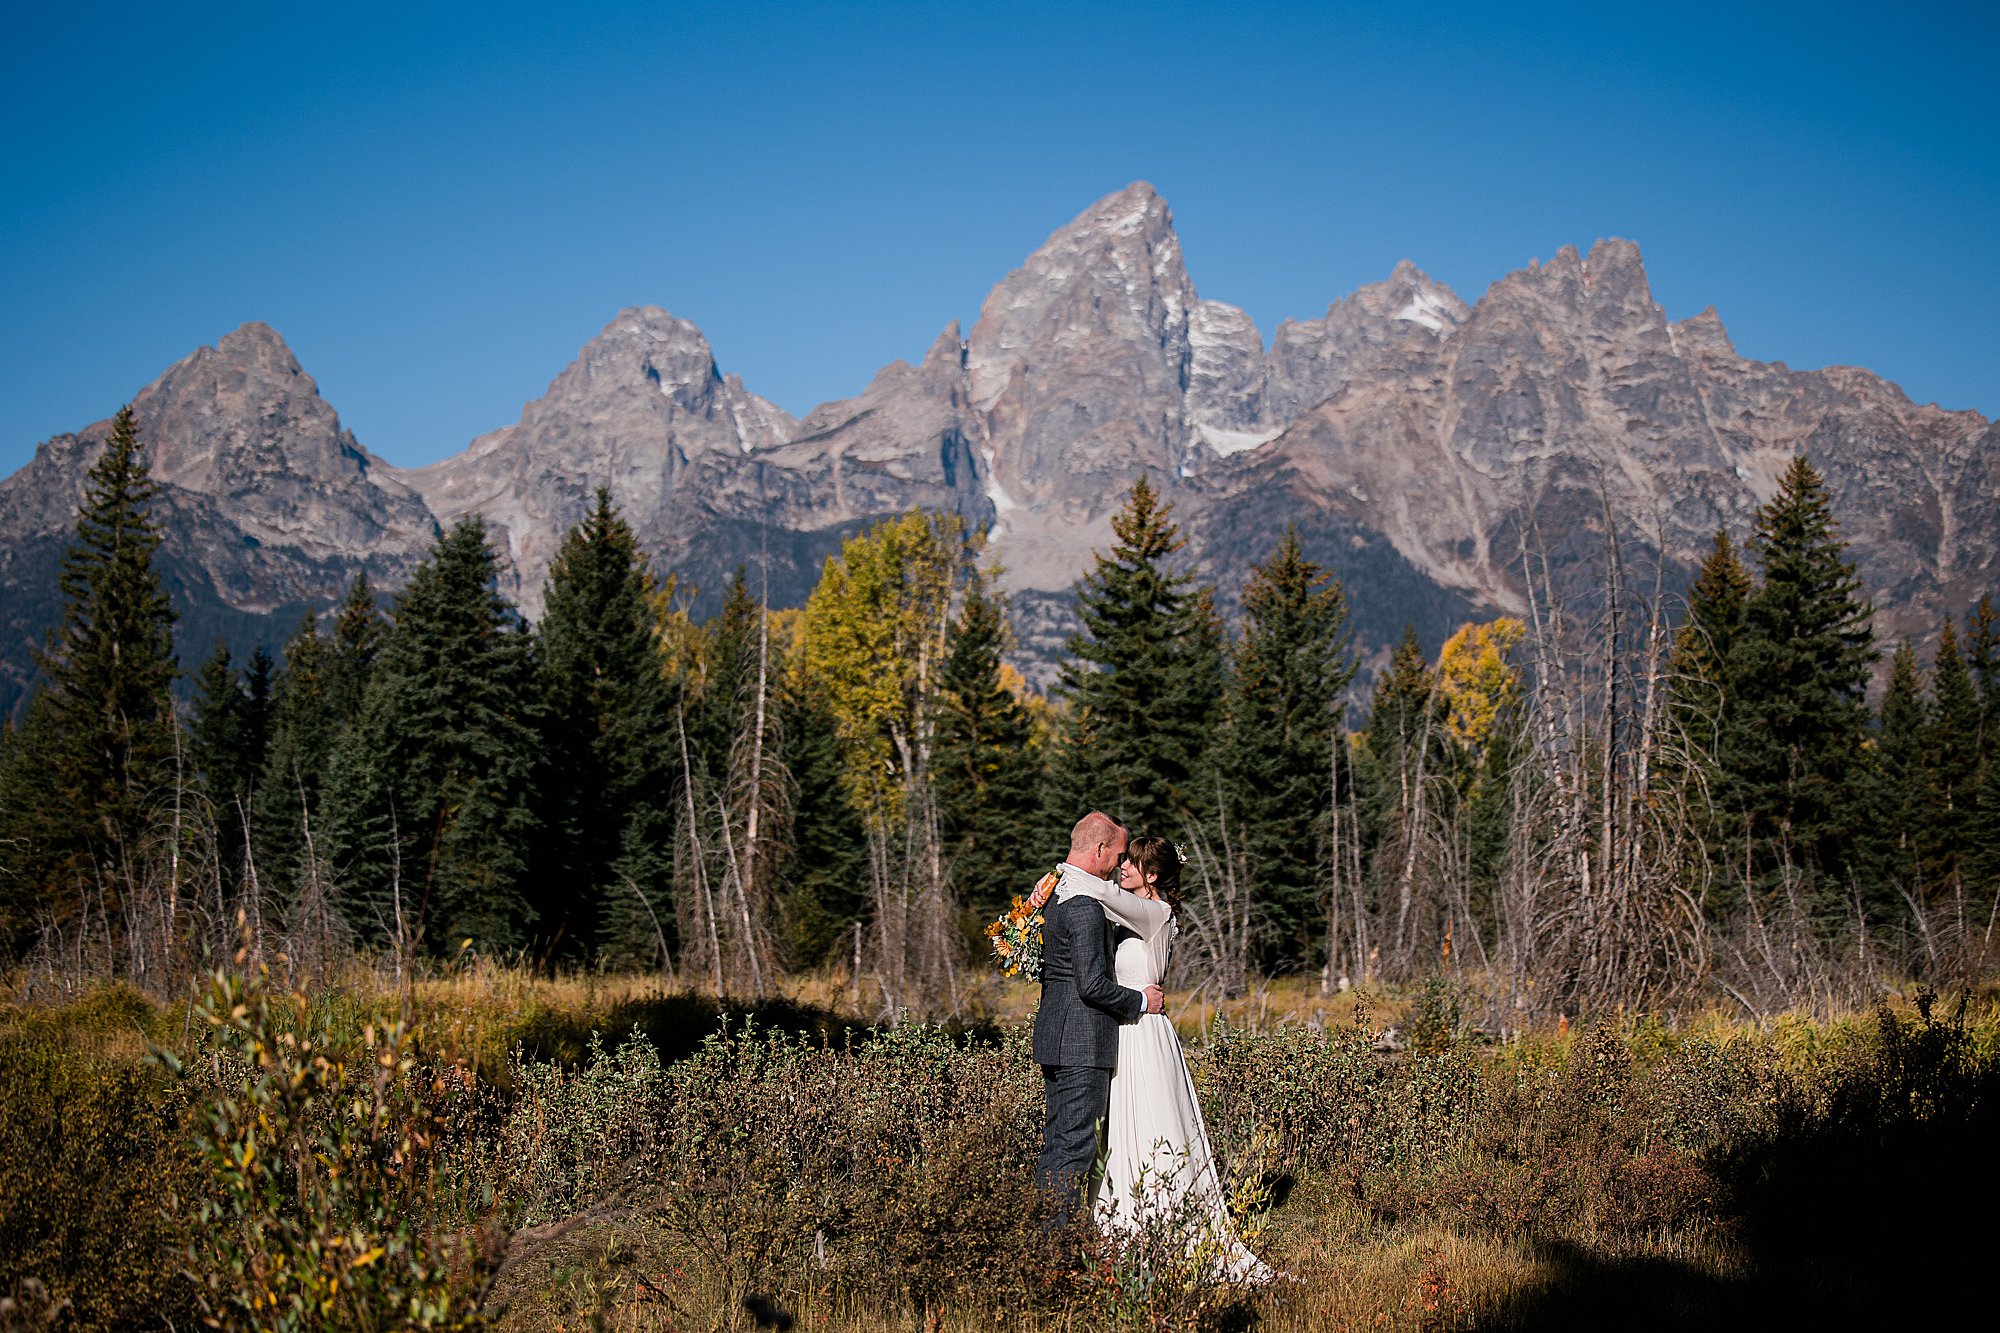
[0,184,2000,707]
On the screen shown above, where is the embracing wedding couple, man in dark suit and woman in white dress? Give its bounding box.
[1030,811,1272,1283]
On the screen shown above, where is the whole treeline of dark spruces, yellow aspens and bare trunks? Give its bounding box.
[0,410,2000,1015]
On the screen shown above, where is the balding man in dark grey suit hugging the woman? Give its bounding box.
[1034,811,1164,1227]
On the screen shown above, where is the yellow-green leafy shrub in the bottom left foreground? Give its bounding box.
[160,956,498,1331]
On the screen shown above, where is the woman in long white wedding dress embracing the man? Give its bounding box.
[1034,837,1272,1283]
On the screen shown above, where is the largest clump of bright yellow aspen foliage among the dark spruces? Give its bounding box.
[804,510,968,819]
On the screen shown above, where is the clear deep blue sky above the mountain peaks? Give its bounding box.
[0,0,2000,472]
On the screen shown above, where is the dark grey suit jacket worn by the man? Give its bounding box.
[1034,872,1146,1069]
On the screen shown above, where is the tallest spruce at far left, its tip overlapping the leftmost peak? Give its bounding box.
[0,406,178,947]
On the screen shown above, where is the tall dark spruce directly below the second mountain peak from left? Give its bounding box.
[536,486,676,967]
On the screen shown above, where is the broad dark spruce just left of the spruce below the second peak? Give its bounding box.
[326,516,540,953]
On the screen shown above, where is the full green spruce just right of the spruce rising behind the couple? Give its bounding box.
[1224,526,1356,967]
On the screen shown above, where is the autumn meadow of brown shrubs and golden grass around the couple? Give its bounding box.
[0,967,2000,1329]
